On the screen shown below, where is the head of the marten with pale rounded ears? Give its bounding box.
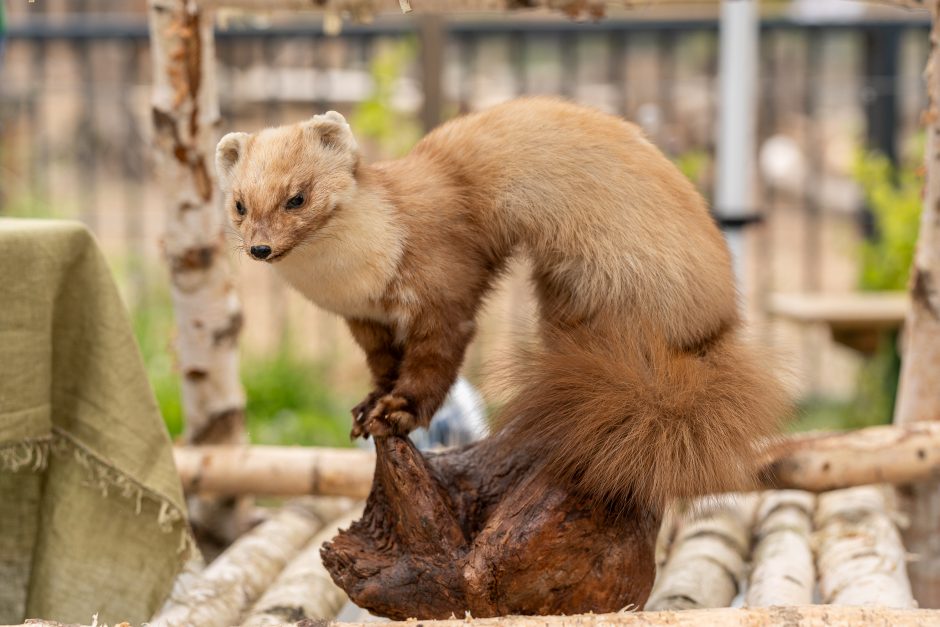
[215,111,359,261]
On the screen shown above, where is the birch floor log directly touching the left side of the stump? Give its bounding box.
[242,506,362,627]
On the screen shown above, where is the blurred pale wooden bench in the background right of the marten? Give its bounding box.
[767,292,910,354]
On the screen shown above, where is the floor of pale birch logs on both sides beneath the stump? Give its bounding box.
[12,486,940,627]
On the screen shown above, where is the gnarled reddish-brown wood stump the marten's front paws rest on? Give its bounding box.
[321,431,661,620]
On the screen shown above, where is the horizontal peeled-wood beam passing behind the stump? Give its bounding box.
[174,423,940,498]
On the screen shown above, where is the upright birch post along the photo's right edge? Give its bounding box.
[894,0,940,607]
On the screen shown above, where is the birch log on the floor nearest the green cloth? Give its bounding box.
[150,502,330,627]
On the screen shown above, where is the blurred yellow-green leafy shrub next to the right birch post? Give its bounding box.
[854,153,924,290]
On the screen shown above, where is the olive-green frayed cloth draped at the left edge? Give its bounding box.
[0,219,192,624]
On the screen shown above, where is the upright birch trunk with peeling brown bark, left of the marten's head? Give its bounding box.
[149,0,246,543]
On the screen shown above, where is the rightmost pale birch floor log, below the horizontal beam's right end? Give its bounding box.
[816,486,916,607]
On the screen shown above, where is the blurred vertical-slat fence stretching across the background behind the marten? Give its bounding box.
[0,16,927,394]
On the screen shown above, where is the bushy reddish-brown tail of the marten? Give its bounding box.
[496,324,787,510]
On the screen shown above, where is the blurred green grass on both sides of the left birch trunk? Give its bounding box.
[132,291,349,446]
